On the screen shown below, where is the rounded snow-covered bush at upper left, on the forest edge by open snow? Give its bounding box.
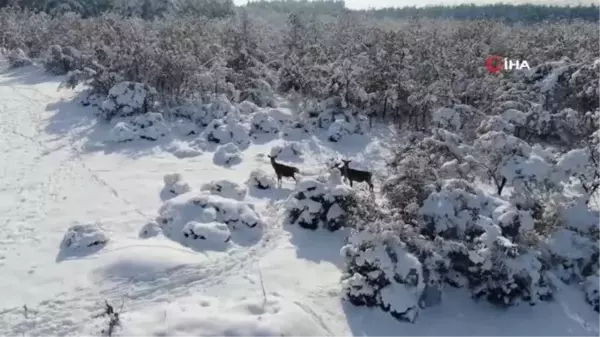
[101,81,156,120]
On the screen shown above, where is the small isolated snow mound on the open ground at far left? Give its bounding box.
[60,224,108,257]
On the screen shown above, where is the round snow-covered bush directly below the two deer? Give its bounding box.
[286,169,356,231]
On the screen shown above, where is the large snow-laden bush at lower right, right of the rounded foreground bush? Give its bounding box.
[419,180,552,306]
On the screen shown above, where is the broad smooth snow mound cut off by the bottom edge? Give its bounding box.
[113,294,330,337]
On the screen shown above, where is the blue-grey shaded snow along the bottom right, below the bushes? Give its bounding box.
[342,287,599,337]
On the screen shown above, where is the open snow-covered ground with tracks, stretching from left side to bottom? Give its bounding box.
[0,62,600,337]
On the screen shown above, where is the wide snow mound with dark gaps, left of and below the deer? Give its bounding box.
[157,191,263,248]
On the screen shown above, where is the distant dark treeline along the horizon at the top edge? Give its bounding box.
[0,0,600,23]
